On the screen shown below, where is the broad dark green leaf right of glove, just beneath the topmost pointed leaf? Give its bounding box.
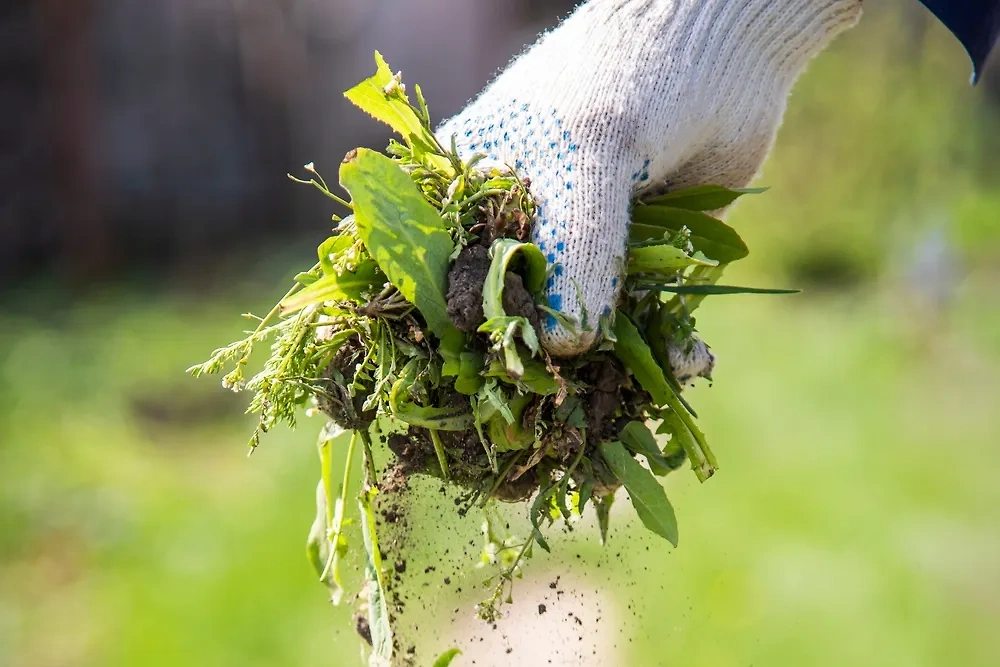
[629,206,750,264]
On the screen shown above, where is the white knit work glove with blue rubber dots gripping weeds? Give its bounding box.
[438,0,861,356]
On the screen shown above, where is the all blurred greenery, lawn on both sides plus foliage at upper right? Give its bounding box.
[0,3,1000,667]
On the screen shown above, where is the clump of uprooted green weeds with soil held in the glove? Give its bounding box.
[190,54,796,664]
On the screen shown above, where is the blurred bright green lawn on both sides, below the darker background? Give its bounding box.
[0,277,1000,666]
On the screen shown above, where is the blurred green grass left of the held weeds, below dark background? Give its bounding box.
[0,294,356,665]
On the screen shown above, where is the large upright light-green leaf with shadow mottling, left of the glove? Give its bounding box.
[340,148,454,338]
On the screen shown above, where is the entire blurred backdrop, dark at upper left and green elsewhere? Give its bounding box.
[0,0,1000,667]
